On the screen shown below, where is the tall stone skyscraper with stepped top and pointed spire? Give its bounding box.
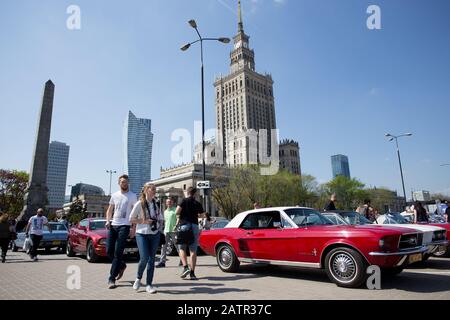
[214,1,276,165]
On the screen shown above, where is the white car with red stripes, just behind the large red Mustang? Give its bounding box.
[375,213,448,258]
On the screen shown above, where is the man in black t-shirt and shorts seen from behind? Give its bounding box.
[176,187,205,280]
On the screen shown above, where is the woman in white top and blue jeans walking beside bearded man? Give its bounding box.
[130,183,164,293]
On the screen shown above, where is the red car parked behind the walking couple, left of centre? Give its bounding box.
[66,218,139,262]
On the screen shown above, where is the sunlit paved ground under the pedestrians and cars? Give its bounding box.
[0,252,450,300]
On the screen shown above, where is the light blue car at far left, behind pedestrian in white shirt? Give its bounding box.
[12,222,68,252]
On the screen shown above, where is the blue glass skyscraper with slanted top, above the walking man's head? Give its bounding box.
[124,111,153,194]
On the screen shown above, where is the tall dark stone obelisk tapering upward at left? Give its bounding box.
[19,80,55,221]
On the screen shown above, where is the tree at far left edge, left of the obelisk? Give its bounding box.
[0,169,29,218]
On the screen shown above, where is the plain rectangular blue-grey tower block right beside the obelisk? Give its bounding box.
[47,141,70,209]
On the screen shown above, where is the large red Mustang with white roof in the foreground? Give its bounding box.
[200,207,427,287]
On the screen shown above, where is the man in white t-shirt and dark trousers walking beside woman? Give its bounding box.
[106,174,137,289]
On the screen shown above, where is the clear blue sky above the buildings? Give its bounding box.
[0,0,450,198]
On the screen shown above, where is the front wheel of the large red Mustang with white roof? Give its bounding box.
[325,247,367,288]
